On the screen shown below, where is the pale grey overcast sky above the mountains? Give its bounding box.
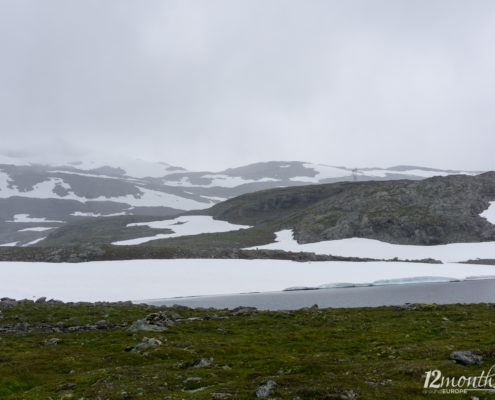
[0,0,495,170]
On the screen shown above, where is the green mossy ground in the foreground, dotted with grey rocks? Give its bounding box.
[0,304,495,400]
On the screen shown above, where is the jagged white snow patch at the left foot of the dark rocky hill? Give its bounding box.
[112,215,251,246]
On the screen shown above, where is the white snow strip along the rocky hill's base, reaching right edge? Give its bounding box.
[248,230,495,262]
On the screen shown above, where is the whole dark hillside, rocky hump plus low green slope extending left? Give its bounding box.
[35,172,495,250]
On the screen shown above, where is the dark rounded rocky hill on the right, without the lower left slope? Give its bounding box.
[206,172,495,245]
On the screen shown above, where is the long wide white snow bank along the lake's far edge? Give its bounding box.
[0,259,495,301]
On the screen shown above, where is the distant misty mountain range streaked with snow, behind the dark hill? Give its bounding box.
[0,156,479,245]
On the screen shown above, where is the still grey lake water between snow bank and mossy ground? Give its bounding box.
[143,279,495,310]
